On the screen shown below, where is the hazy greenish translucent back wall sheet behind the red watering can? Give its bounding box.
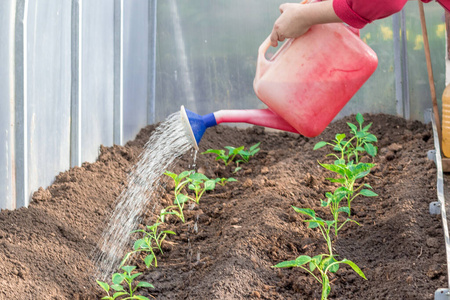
[156,0,444,124]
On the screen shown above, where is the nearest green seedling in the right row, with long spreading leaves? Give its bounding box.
[273,254,367,300]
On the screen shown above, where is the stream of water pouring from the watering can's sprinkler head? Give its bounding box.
[93,112,192,280]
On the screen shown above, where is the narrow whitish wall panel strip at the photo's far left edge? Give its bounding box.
[0,0,15,209]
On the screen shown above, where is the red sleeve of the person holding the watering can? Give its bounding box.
[333,0,442,29]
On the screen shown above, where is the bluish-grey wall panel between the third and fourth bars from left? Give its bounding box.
[123,0,150,141]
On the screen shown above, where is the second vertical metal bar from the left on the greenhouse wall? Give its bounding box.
[70,0,82,167]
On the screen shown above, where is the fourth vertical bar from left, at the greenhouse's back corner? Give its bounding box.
[147,0,158,124]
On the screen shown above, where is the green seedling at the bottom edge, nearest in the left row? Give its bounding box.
[97,266,155,300]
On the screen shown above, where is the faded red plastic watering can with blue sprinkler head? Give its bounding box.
[180,23,378,149]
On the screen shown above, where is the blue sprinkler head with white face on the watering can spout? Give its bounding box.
[180,105,217,150]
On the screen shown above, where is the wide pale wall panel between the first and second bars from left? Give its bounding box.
[27,0,71,204]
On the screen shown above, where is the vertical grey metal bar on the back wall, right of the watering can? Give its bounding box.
[392,13,403,117]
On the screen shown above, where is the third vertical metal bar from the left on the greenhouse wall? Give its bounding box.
[113,0,124,145]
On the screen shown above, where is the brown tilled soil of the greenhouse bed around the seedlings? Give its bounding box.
[0,114,447,300]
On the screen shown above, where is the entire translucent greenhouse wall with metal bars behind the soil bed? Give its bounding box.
[0,0,446,209]
